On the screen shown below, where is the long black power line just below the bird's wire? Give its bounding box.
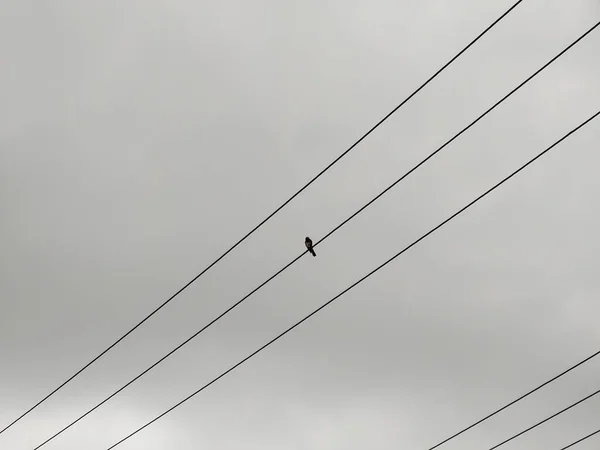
[107,107,600,450]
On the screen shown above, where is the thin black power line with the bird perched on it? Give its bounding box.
[29,18,600,450]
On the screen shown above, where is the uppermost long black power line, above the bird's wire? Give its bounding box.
[0,0,523,434]
